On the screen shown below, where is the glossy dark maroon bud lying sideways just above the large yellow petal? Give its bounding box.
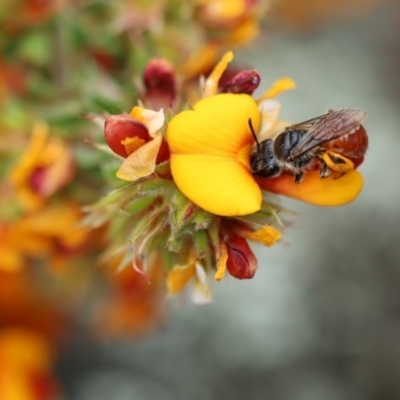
[219,70,261,95]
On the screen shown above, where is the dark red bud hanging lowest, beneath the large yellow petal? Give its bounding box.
[226,235,258,279]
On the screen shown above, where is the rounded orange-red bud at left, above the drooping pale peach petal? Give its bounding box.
[104,114,150,157]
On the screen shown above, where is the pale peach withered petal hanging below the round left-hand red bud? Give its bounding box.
[117,134,162,181]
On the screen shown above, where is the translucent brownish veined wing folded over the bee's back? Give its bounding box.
[286,108,366,160]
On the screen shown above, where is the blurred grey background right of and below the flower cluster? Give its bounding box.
[0,0,400,400]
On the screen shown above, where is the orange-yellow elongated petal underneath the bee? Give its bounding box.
[257,170,364,207]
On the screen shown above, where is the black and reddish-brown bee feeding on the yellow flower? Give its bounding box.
[249,108,368,183]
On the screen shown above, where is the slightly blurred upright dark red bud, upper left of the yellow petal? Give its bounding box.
[143,58,176,110]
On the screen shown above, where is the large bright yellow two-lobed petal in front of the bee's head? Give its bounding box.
[167,94,262,216]
